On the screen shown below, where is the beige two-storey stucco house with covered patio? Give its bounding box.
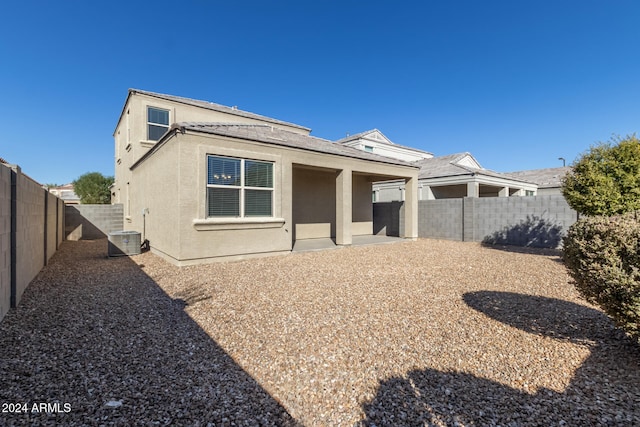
[112,89,419,265]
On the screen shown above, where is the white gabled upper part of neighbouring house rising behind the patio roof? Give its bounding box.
[336,129,433,162]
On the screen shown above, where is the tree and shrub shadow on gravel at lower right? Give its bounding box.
[362,291,640,426]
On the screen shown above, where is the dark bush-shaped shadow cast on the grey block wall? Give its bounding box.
[482,215,562,249]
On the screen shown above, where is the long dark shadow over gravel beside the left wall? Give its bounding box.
[0,240,296,426]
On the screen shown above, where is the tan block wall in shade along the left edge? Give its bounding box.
[0,164,64,319]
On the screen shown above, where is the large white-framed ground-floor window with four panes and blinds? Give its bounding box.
[207,156,273,218]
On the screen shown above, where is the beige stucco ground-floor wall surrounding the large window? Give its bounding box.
[130,132,417,264]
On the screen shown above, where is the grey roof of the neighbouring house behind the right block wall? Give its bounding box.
[414,152,529,182]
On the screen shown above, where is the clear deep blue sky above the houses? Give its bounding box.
[0,0,640,184]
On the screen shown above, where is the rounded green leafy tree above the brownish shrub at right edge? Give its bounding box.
[562,135,640,216]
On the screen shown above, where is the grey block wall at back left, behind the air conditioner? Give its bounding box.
[65,204,124,240]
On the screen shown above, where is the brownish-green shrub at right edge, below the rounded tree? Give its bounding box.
[563,212,640,342]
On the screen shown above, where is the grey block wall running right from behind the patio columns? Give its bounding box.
[374,195,578,249]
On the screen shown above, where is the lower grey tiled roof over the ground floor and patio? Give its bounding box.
[131,122,417,169]
